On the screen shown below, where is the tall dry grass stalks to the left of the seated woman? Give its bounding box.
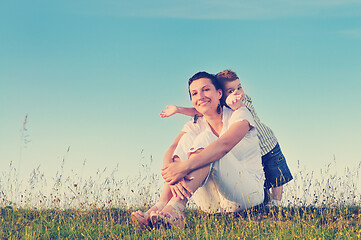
[0,147,160,210]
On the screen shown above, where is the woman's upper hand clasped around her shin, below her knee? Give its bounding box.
[162,162,189,185]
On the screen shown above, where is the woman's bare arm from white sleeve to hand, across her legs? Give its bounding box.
[162,120,250,184]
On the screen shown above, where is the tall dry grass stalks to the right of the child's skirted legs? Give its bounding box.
[283,159,361,207]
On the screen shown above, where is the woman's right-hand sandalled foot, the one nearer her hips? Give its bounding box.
[150,201,185,229]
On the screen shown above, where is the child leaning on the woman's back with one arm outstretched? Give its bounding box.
[160,70,293,205]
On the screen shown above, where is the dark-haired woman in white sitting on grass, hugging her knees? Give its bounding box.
[131,72,264,228]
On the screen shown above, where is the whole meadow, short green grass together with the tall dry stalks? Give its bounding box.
[0,117,361,239]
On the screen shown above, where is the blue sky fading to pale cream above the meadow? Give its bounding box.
[0,0,361,182]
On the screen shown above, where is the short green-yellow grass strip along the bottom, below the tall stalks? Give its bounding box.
[0,206,361,239]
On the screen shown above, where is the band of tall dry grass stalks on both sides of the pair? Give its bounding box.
[0,154,361,210]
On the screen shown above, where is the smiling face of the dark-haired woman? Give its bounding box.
[189,78,222,115]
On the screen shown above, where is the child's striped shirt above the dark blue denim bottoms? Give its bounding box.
[242,94,278,156]
